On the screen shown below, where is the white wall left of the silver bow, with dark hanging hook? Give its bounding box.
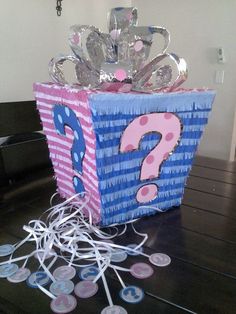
[0,0,131,102]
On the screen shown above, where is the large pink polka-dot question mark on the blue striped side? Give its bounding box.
[120,112,181,203]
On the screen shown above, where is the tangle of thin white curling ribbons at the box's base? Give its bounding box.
[0,193,171,312]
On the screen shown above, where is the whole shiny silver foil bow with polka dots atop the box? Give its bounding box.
[49,8,188,92]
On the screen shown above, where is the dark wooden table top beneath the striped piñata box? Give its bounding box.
[0,157,236,314]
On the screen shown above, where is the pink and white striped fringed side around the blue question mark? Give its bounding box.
[34,83,101,222]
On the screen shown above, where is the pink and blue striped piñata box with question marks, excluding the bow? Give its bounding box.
[34,83,215,225]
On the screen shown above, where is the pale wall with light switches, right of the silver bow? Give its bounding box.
[132,0,236,159]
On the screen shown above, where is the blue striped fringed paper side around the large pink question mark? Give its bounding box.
[90,91,215,225]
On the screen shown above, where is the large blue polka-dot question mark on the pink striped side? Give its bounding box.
[53,105,85,193]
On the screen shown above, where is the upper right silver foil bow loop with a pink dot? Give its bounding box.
[118,26,170,74]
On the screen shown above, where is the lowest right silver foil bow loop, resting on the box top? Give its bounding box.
[133,53,188,92]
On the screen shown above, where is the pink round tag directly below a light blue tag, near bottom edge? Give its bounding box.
[50,294,77,314]
